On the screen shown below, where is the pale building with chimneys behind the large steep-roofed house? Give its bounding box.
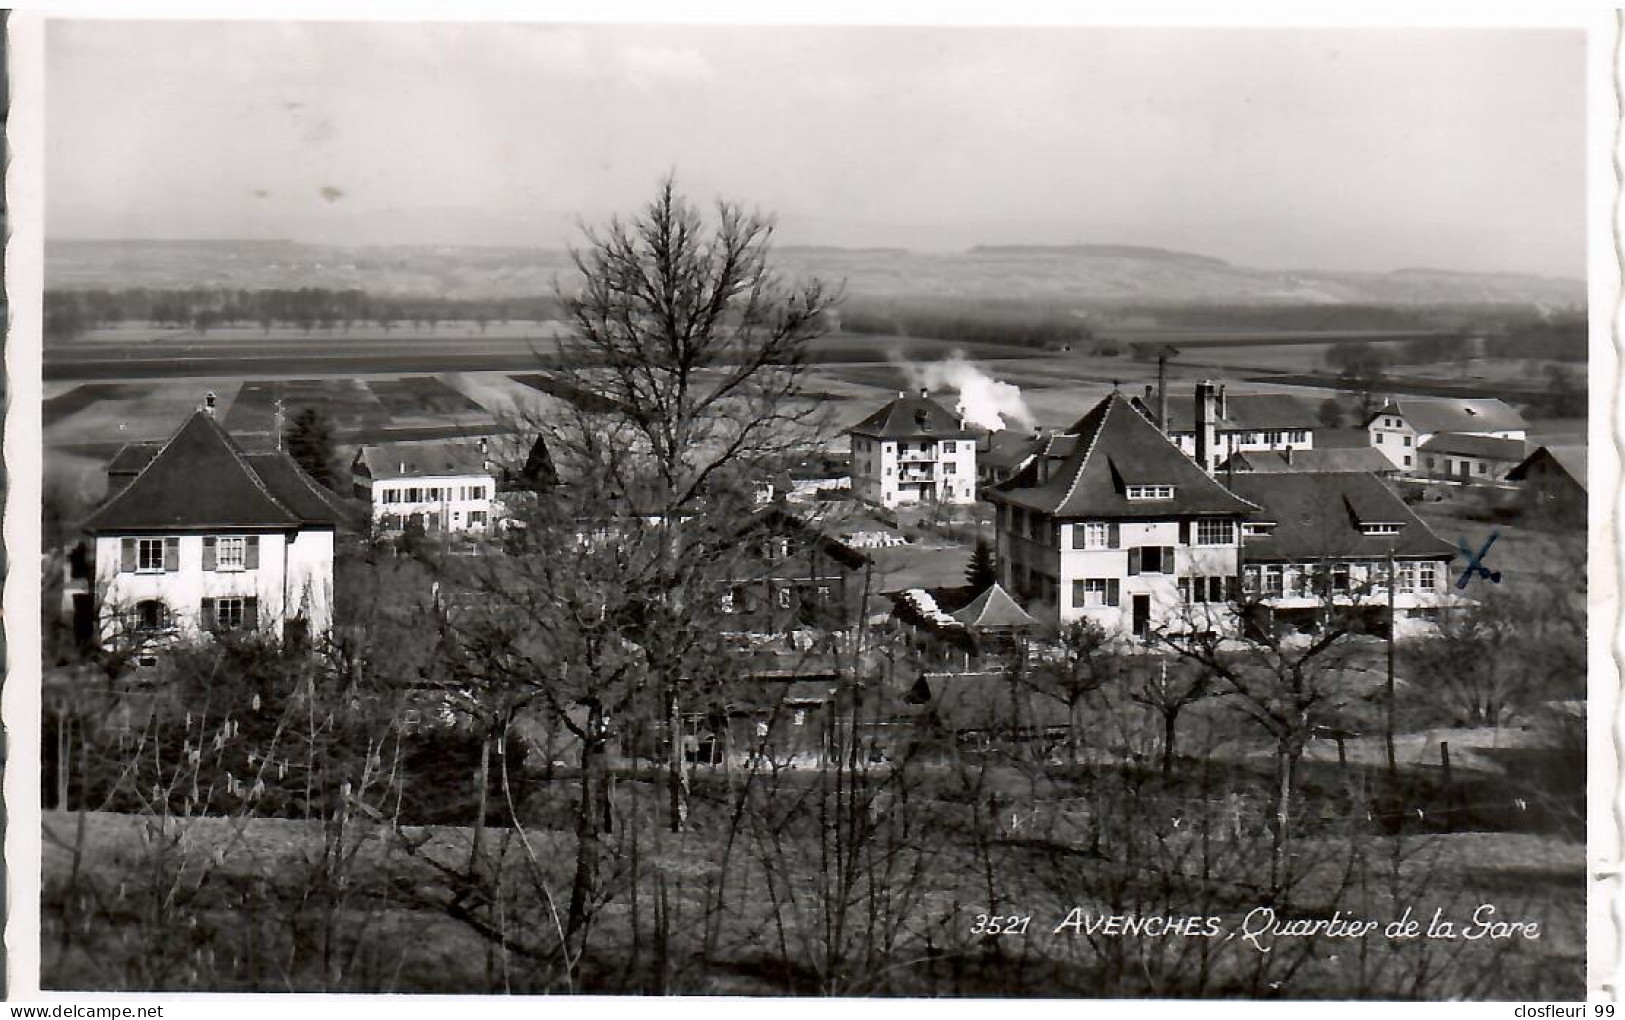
[1134,380,1320,471]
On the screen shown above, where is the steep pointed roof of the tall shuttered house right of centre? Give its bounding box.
[986,390,1256,518]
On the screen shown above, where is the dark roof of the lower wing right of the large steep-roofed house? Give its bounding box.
[1233,471,1456,564]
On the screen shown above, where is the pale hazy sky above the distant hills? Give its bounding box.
[46,21,1586,278]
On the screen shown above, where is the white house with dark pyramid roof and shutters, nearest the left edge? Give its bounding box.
[75,401,345,646]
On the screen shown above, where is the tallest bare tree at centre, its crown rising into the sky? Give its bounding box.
[548,177,835,830]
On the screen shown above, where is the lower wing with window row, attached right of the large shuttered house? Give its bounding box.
[1230,473,1456,635]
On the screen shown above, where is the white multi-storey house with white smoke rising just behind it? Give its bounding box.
[848,390,978,507]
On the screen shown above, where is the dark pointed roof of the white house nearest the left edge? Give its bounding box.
[85,411,343,534]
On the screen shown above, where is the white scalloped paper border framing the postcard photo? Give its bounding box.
[0,0,1625,1017]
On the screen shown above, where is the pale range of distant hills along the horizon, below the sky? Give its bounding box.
[46,240,1586,310]
